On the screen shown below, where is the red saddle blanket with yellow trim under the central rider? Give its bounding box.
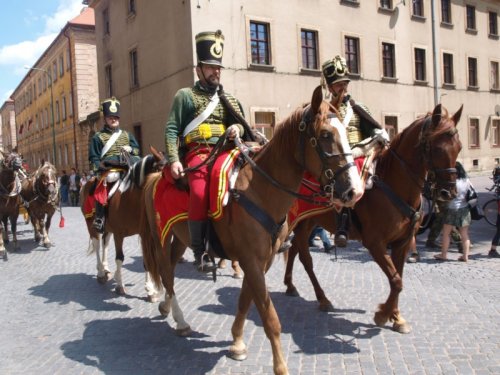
[153,149,240,246]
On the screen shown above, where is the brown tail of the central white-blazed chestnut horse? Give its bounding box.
[139,175,162,288]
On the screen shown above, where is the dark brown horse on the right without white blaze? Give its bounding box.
[284,105,463,333]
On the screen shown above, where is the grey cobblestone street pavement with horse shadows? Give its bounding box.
[0,176,500,375]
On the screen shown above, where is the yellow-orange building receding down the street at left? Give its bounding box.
[12,8,99,171]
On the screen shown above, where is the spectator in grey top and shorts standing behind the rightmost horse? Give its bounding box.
[434,161,471,262]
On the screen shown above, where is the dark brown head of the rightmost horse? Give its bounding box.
[420,104,463,201]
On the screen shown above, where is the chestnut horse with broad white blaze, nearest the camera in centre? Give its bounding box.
[141,87,361,374]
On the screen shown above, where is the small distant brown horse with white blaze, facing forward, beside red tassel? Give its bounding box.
[20,161,59,249]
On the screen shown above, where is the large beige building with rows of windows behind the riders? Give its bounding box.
[89,0,500,171]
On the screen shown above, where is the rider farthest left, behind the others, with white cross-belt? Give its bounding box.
[89,97,139,233]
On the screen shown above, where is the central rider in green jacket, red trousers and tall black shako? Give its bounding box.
[165,30,250,272]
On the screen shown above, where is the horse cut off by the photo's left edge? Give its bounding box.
[0,151,23,260]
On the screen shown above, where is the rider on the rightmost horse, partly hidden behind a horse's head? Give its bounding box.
[322,55,389,247]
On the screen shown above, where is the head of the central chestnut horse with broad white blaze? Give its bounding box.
[296,86,362,206]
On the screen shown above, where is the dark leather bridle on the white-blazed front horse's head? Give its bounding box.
[299,105,355,194]
